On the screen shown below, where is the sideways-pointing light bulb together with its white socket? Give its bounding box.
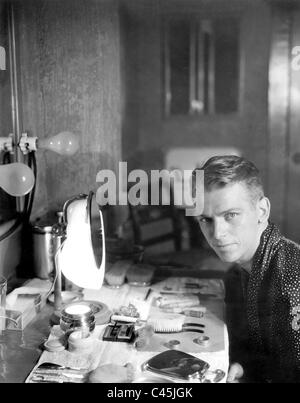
[19,131,79,155]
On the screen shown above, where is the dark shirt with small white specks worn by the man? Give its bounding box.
[225,223,300,382]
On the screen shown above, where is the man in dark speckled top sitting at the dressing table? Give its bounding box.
[194,156,300,382]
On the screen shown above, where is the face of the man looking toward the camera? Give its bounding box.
[199,183,261,264]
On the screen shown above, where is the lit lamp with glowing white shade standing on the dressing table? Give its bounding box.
[54,192,106,322]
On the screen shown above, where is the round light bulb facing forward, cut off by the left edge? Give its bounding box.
[0,162,35,196]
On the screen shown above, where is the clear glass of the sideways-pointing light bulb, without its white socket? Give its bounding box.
[37,132,79,155]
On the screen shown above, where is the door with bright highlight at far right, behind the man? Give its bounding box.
[268,5,300,242]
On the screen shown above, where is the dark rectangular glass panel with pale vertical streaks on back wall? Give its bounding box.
[164,16,239,116]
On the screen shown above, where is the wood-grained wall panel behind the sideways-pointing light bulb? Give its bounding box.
[15,0,121,218]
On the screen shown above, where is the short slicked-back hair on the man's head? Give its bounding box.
[193,155,264,202]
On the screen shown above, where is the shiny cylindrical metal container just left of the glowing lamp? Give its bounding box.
[32,220,54,279]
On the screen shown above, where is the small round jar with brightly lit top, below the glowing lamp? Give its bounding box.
[60,302,96,337]
